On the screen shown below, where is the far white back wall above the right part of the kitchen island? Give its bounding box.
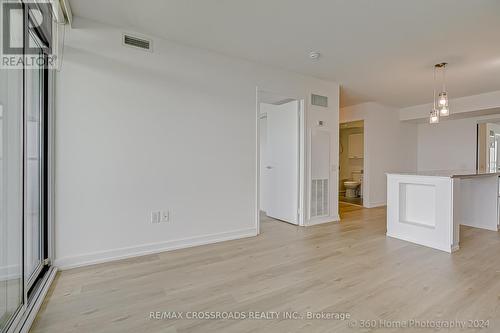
[418,115,500,171]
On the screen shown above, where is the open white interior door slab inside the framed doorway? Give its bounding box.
[266,101,299,224]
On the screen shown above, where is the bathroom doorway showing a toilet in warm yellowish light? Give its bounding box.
[339,120,365,206]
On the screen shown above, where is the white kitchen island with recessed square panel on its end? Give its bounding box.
[387,171,499,253]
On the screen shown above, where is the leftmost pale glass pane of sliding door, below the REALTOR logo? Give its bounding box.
[0,64,24,331]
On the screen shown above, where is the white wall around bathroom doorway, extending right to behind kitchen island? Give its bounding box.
[340,102,417,207]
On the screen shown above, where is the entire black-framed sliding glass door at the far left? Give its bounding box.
[0,0,55,333]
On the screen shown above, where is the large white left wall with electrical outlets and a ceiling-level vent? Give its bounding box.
[56,18,339,267]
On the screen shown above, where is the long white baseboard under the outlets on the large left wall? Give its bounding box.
[54,228,257,270]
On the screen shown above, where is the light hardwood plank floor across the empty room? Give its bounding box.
[31,205,500,333]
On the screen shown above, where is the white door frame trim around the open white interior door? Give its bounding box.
[255,87,307,235]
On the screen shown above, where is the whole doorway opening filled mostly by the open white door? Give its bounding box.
[257,91,304,232]
